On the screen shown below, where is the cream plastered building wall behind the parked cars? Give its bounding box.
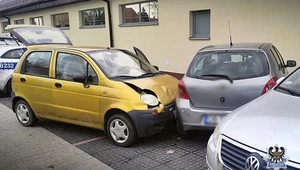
[4,0,300,73]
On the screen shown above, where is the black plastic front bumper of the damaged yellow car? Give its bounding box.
[128,104,176,137]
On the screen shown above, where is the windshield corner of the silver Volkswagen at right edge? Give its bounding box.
[276,68,300,96]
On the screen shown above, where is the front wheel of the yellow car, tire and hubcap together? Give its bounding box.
[106,114,138,147]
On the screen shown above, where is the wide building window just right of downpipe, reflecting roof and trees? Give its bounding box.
[121,1,158,25]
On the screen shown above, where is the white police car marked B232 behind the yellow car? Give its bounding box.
[0,42,26,95]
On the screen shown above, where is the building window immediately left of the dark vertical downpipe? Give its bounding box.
[81,8,105,26]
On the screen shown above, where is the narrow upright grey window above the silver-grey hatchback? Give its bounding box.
[191,10,210,39]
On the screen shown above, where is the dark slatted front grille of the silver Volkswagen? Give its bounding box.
[221,140,299,170]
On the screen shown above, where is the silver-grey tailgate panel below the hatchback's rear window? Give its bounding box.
[184,76,270,110]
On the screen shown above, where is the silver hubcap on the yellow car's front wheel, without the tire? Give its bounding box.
[109,119,129,143]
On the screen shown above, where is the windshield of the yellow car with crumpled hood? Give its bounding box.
[87,50,158,78]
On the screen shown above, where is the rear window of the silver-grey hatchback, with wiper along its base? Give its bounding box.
[187,51,269,80]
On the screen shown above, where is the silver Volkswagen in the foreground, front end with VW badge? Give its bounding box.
[206,67,300,170]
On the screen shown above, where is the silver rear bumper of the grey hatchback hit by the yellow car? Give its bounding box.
[176,98,232,131]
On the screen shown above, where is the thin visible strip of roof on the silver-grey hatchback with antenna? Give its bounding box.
[199,42,271,52]
